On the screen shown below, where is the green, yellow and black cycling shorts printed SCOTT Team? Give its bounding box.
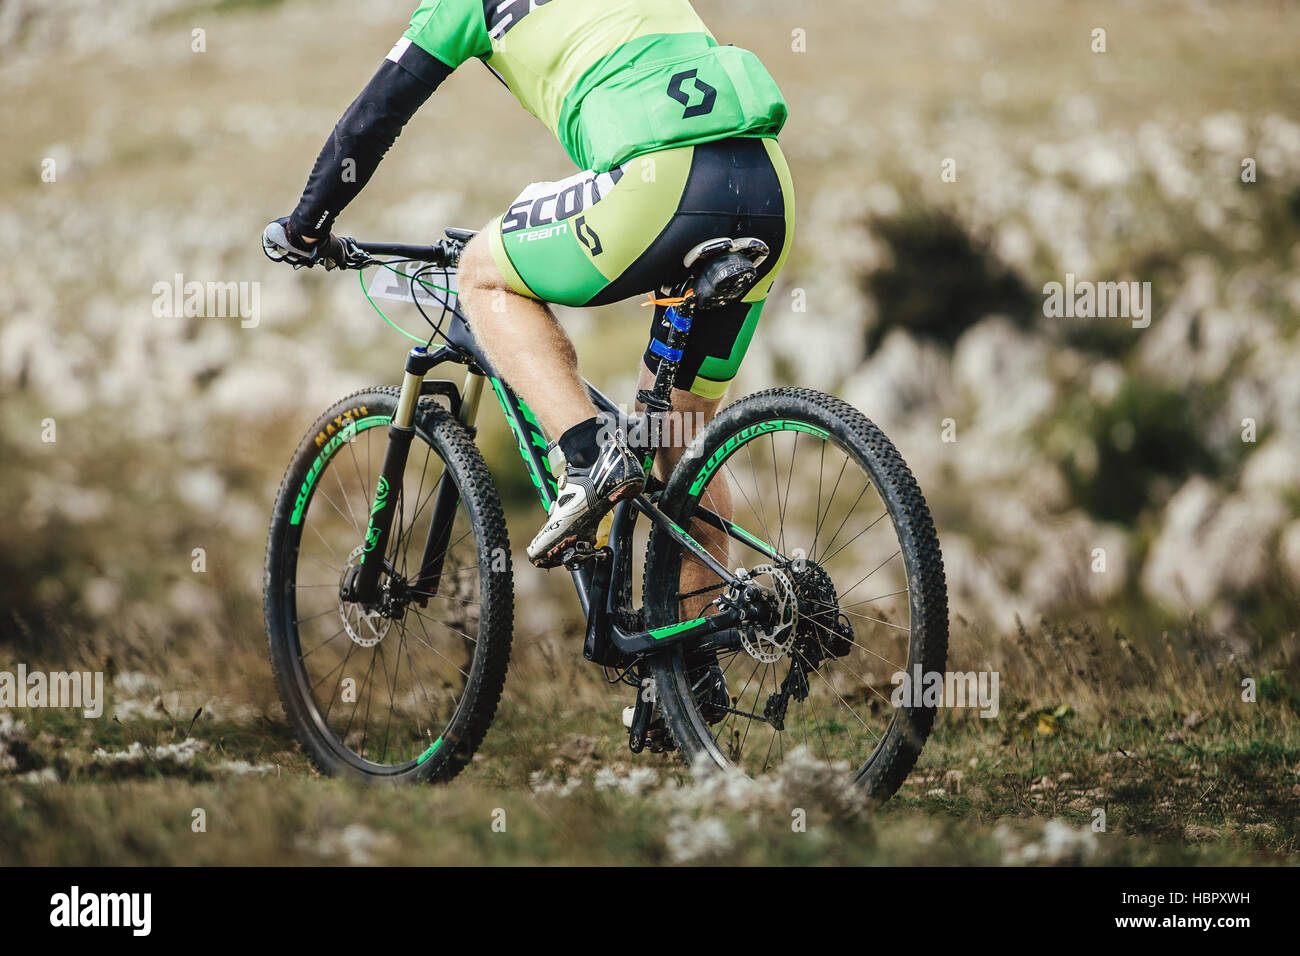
[488,137,794,398]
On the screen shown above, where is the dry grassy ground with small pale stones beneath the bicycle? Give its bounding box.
[0,613,1300,865]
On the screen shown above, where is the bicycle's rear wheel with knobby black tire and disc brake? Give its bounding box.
[645,388,948,801]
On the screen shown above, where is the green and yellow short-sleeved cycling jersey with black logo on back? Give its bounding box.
[403,0,787,173]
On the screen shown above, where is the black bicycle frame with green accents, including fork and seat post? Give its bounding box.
[341,261,783,665]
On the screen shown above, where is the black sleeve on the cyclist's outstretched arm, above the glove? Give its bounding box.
[290,43,451,238]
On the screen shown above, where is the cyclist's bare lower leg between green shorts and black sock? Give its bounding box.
[459,235,597,437]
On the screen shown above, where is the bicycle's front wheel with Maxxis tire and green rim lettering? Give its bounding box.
[264,386,514,782]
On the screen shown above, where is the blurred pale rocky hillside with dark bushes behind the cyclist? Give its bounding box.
[0,0,1300,702]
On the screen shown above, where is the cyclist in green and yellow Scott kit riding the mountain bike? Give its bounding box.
[264,0,794,572]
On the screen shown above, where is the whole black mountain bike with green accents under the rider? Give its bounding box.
[264,229,948,800]
